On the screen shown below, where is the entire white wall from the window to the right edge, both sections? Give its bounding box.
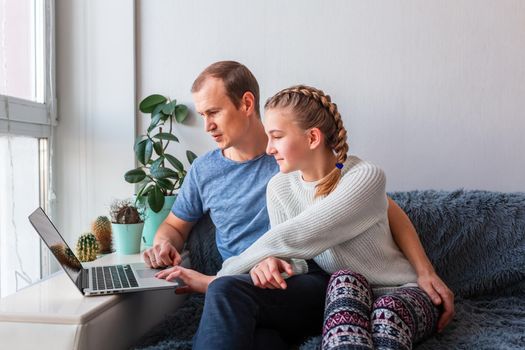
[55,0,525,243]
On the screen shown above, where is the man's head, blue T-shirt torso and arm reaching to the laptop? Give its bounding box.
[144,62,279,292]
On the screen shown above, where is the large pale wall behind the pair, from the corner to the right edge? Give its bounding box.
[137,0,525,191]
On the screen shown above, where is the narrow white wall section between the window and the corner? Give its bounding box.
[54,0,135,243]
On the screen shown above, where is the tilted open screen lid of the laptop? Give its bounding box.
[29,208,84,294]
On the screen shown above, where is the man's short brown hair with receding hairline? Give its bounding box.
[191,61,261,116]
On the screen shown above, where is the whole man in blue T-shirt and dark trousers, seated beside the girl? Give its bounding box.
[144,61,453,349]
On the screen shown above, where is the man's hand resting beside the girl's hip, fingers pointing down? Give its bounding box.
[417,271,456,332]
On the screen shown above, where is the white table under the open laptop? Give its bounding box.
[0,253,188,350]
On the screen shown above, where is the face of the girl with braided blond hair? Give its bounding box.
[264,108,311,173]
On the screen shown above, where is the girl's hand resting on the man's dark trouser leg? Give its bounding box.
[250,257,293,289]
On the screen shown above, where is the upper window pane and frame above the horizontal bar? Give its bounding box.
[0,0,56,137]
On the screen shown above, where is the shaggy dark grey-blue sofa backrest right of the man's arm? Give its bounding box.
[390,190,525,297]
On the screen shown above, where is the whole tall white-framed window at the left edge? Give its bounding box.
[0,0,56,297]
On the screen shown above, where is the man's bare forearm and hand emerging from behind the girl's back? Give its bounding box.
[388,197,455,332]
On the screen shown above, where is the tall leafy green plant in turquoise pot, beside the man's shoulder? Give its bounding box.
[124,94,197,246]
